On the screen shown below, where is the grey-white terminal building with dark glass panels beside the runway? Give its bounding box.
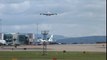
[0,33,35,45]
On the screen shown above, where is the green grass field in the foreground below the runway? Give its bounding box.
[0,51,106,60]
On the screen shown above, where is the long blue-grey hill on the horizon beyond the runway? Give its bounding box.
[56,36,106,44]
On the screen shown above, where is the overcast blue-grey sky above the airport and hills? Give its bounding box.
[0,0,106,37]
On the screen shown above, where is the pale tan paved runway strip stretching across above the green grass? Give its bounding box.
[0,44,106,52]
